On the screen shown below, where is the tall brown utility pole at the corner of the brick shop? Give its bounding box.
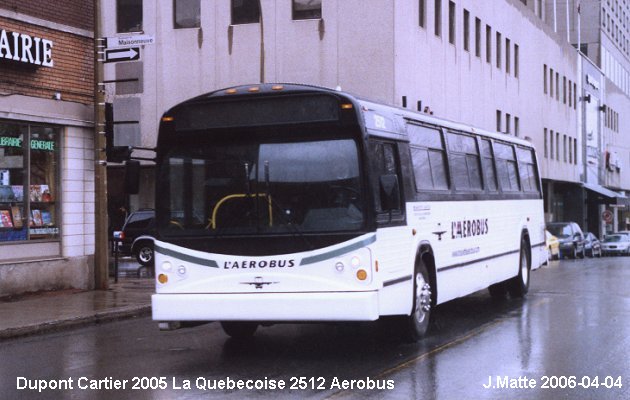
[94,0,109,290]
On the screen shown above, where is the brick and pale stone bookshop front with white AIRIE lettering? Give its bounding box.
[0,1,94,297]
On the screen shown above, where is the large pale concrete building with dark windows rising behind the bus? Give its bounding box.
[102,0,630,236]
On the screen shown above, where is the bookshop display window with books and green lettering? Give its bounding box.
[0,122,61,242]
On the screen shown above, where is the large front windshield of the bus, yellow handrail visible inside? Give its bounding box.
[158,139,365,236]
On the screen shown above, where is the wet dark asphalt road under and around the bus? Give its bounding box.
[0,257,630,399]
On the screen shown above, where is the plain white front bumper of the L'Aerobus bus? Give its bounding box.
[151,291,379,322]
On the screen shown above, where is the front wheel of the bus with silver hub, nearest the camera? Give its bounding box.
[403,260,433,342]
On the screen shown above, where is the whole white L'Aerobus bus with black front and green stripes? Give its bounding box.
[144,84,546,340]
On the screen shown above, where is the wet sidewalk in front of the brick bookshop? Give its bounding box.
[0,260,155,340]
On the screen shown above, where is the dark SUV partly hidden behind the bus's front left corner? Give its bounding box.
[114,208,155,266]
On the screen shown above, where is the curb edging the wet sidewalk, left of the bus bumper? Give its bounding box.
[0,305,151,341]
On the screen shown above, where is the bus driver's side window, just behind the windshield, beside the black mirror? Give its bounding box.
[372,141,402,215]
